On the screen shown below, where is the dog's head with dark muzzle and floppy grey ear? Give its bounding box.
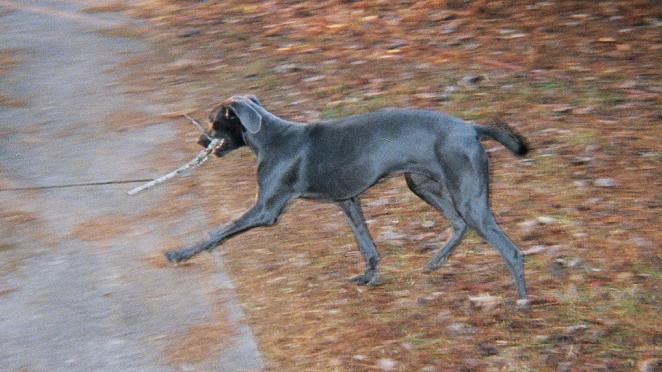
[198,96,262,157]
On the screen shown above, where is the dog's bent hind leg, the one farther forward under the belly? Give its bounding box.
[405,173,467,272]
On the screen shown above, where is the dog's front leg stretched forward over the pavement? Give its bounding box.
[165,196,290,262]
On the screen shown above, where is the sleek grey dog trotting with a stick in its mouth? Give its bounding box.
[166,96,528,299]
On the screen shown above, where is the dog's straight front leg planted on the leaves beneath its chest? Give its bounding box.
[340,198,381,285]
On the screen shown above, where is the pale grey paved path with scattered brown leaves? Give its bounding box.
[0,0,263,371]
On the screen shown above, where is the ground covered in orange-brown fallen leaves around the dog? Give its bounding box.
[96,0,662,371]
